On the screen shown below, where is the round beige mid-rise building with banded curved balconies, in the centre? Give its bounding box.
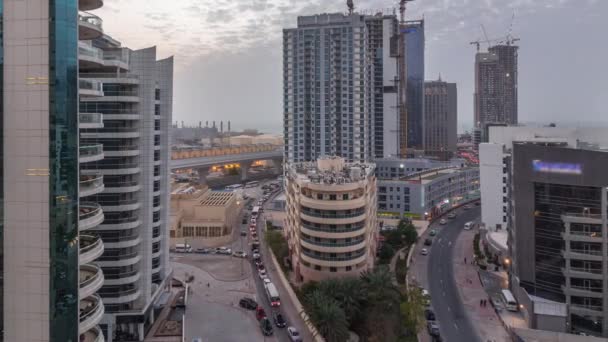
[284,157,378,283]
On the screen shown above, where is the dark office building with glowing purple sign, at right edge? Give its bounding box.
[508,143,608,337]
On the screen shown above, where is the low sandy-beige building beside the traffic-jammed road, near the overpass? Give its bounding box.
[171,184,242,248]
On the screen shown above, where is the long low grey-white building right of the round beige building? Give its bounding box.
[378,166,479,218]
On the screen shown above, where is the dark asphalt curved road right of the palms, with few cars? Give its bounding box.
[427,207,481,342]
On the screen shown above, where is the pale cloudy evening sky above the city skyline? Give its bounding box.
[94,0,608,133]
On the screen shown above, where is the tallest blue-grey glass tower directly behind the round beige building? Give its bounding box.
[283,13,398,162]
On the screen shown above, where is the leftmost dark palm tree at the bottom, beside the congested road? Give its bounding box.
[306,290,349,342]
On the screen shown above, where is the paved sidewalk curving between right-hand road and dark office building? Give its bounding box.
[452,231,511,342]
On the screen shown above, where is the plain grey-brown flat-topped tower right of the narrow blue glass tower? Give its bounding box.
[424,79,458,160]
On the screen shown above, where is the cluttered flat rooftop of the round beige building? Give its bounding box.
[287,156,376,184]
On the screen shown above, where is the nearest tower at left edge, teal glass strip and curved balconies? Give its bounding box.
[0,0,104,342]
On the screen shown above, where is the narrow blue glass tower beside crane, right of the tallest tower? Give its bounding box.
[401,20,424,149]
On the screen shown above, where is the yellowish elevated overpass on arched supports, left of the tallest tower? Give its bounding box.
[171,146,283,183]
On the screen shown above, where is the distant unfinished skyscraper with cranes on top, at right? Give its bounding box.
[475,44,519,131]
